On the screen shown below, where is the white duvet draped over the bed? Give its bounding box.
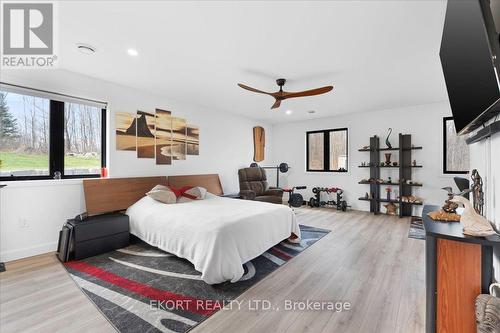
[127,193,300,284]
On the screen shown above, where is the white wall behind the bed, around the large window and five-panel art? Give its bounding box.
[0,70,272,261]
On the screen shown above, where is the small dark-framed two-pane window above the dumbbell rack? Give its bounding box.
[306,128,349,172]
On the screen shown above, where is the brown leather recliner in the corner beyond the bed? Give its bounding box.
[238,167,283,204]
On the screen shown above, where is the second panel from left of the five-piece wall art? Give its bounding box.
[135,111,155,158]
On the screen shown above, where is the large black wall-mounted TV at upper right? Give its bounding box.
[439,0,500,134]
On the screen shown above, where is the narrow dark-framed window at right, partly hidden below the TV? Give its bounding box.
[443,117,470,174]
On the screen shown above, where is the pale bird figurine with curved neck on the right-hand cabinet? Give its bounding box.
[450,196,496,237]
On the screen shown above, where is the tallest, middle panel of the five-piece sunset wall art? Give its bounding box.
[155,109,172,164]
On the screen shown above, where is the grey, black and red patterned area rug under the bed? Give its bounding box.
[65,225,330,333]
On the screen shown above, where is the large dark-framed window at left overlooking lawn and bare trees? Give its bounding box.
[0,90,106,181]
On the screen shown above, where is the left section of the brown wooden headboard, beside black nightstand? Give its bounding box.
[83,176,167,215]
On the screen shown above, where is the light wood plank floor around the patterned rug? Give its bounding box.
[0,208,425,333]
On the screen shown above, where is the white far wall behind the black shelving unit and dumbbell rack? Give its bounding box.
[272,103,454,214]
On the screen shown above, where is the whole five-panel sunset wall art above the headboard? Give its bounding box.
[115,109,200,165]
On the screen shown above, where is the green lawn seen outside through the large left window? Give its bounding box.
[0,152,101,171]
